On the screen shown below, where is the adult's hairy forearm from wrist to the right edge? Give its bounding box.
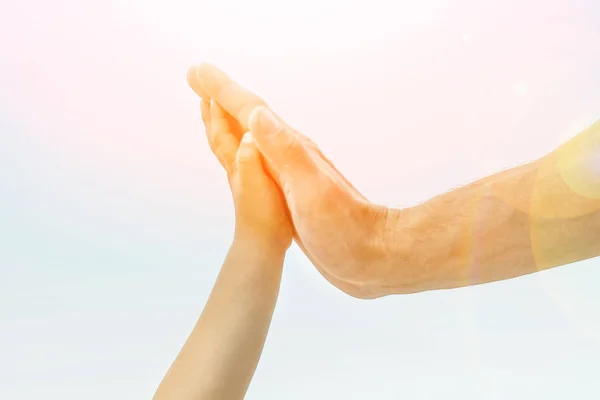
[382,119,600,293]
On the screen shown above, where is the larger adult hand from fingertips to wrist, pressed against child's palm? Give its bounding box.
[188,64,387,298]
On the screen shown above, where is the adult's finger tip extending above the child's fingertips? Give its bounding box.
[192,63,266,131]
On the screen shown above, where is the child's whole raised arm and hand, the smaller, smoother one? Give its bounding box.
[154,102,293,400]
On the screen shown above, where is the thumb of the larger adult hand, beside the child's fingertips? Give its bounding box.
[248,106,310,173]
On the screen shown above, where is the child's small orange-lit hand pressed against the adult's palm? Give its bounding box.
[202,100,294,251]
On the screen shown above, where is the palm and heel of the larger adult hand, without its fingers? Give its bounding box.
[268,132,380,297]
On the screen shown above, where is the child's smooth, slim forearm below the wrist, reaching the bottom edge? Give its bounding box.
[154,240,286,400]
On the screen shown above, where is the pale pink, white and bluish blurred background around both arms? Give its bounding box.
[0,0,600,400]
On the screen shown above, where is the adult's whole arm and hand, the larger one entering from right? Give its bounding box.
[188,64,600,298]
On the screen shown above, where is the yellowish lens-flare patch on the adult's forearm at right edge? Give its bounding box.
[530,121,600,270]
